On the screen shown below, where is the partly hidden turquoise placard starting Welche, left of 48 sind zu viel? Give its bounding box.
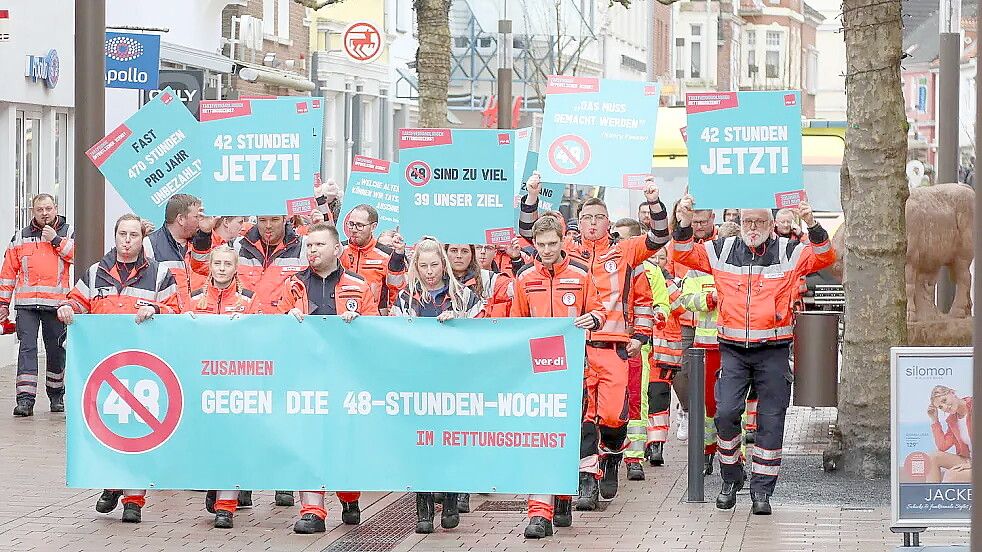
[338,155,402,239]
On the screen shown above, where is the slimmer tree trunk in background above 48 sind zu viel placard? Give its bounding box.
[414,0,450,128]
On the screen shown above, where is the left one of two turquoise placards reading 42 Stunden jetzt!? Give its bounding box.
[200,97,324,216]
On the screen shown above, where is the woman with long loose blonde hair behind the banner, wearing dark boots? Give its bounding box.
[389,237,482,533]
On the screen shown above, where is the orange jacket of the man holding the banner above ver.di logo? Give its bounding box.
[509,253,607,328]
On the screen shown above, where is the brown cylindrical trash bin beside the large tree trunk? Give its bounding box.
[794,312,839,406]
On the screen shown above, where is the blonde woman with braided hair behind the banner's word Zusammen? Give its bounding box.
[190,245,252,529]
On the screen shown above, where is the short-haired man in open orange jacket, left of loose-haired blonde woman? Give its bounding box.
[280,222,379,534]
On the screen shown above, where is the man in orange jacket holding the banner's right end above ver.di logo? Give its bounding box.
[510,217,607,539]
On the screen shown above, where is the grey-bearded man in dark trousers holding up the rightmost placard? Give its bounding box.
[673,195,835,515]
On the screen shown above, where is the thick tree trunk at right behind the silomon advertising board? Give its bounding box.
[827,0,908,477]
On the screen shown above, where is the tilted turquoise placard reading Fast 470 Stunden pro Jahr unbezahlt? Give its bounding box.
[85,87,206,226]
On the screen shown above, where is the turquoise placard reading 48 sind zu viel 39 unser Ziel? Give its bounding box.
[399,128,528,244]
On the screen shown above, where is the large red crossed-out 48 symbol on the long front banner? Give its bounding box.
[82,350,184,454]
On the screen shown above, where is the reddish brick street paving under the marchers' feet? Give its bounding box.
[0,366,968,552]
